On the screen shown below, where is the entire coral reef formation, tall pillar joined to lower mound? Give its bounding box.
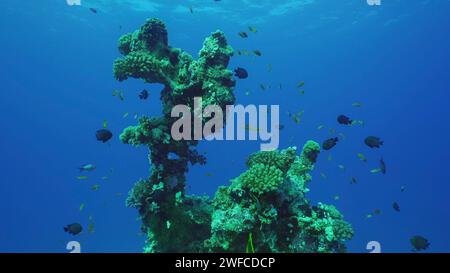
[114,19,353,252]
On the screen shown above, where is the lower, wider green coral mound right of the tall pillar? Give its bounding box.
[206,146,353,252]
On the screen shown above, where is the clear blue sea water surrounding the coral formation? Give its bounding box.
[0,0,450,252]
